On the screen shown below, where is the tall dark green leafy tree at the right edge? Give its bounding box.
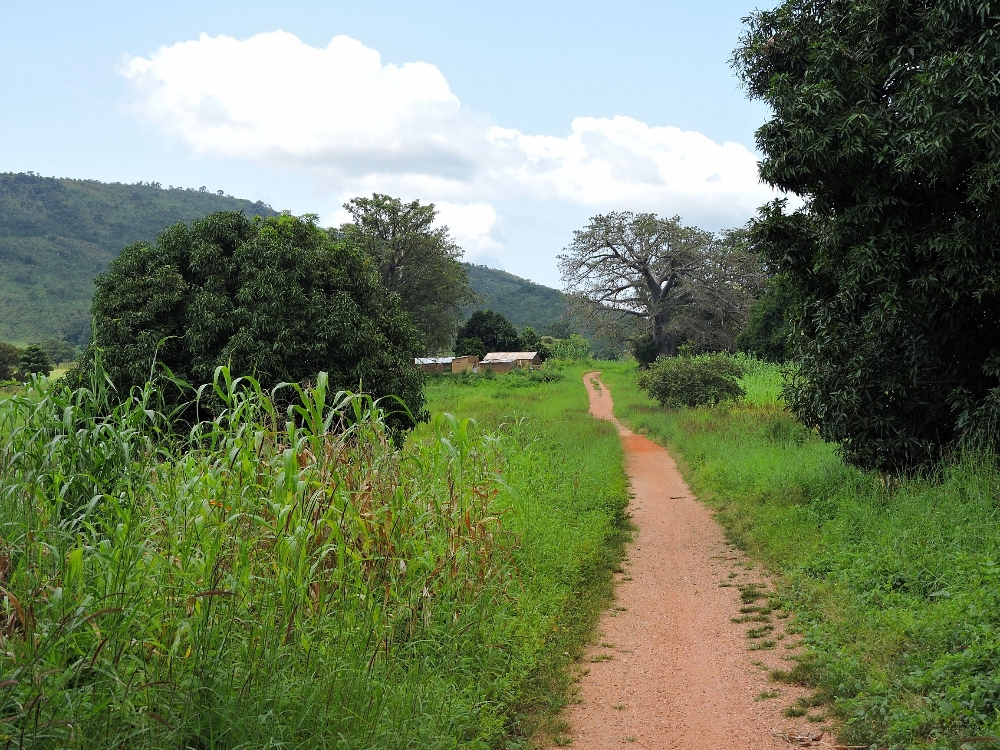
[734,0,1000,470]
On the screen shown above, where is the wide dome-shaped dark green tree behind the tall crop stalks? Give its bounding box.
[70,212,424,427]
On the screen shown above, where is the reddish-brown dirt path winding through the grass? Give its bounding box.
[556,373,820,750]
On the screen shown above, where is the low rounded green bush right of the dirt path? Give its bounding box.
[639,354,746,409]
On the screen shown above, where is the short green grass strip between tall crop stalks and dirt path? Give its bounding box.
[424,366,630,748]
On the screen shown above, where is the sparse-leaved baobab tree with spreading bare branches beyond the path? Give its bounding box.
[559,211,762,356]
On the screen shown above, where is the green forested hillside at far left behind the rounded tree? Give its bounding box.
[0,173,277,343]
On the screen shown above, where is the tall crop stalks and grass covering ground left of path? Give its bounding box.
[0,370,627,749]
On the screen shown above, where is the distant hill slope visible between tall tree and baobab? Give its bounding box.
[463,263,568,332]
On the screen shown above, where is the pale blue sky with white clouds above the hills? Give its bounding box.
[0,0,773,287]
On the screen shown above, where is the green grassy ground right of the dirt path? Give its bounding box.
[603,363,1000,748]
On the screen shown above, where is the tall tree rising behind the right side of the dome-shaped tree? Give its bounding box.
[340,193,476,353]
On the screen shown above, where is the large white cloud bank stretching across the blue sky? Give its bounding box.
[123,31,773,264]
